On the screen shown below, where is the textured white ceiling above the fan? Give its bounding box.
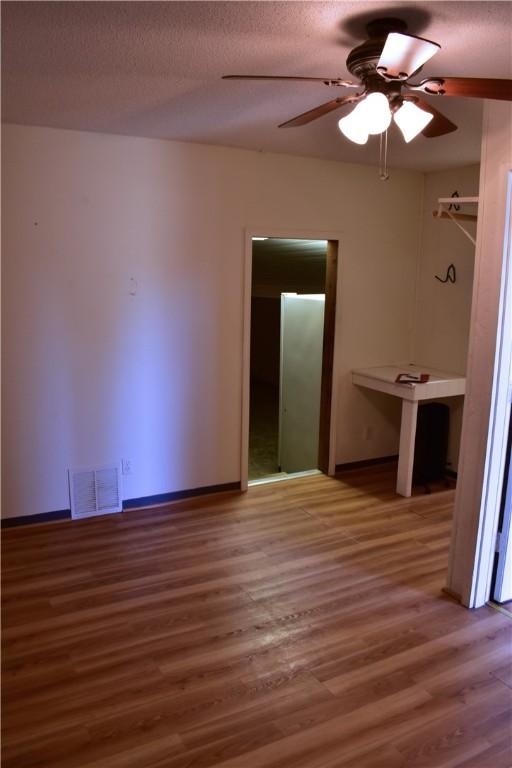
[1,0,512,170]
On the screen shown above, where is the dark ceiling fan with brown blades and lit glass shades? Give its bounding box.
[223,18,512,144]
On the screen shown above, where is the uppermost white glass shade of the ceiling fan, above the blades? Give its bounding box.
[377,32,441,80]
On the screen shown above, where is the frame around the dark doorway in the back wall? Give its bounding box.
[240,226,342,491]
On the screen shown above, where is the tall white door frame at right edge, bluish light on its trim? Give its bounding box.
[446,100,512,608]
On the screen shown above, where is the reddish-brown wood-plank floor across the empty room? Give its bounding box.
[2,466,512,768]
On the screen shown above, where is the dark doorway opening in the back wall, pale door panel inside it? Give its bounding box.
[248,237,338,484]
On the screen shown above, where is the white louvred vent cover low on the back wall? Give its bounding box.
[69,465,123,519]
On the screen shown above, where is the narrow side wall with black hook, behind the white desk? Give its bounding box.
[413,165,480,471]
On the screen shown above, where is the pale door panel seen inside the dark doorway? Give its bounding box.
[279,293,325,472]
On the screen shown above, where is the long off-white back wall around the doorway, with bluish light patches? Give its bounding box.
[2,126,423,516]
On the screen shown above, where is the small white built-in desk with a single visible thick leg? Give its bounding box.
[352,365,466,496]
